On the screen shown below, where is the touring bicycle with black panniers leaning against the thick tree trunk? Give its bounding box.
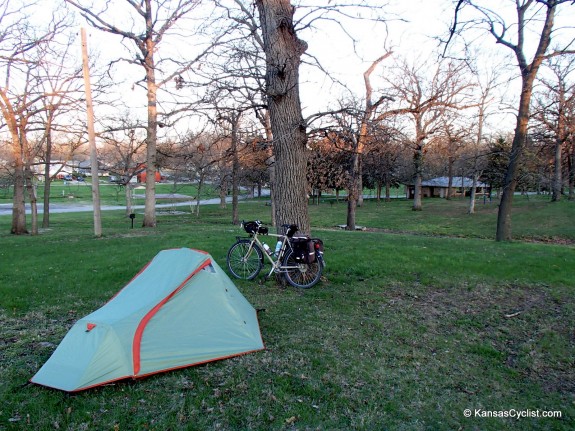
[227,220,325,289]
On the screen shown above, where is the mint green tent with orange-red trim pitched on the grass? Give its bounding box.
[31,248,264,392]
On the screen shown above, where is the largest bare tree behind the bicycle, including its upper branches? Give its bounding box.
[207,0,392,231]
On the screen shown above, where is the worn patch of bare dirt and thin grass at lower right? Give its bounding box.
[402,284,575,392]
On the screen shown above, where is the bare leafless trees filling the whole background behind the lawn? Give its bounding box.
[0,0,575,240]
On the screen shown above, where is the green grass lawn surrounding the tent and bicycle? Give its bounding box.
[0,196,575,431]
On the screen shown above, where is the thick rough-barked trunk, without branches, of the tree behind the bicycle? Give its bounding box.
[256,0,310,233]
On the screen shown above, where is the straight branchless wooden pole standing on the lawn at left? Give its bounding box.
[81,27,102,237]
